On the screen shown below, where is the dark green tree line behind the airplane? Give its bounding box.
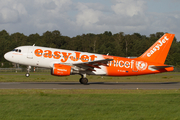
[0,30,180,67]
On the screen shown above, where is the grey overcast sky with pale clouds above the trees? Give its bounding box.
[0,0,180,41]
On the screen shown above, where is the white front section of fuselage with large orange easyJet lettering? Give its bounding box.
[4,46,106,75]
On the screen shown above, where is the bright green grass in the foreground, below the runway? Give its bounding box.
[0,90,180,120]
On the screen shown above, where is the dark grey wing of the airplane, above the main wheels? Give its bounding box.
[73,59,114,71]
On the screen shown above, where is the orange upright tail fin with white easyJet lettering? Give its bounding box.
[139,33,175,64]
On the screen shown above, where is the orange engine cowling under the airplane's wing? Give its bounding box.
[51,64,71,76]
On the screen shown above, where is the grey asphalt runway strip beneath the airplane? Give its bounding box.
[0,82,180,89]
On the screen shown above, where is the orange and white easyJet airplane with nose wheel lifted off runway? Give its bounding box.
[4,33,175,84]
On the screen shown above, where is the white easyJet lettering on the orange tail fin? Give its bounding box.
[147,36,169,57]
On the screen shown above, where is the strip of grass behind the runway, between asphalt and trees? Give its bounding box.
[0,72,180,82]
